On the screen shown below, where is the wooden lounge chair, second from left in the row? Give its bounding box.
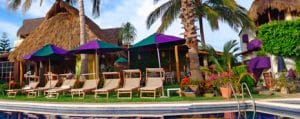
[26,80,58,97]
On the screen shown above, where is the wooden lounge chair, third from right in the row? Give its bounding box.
[95,72,121,98]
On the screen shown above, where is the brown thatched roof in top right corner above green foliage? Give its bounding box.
[249,0,300,21]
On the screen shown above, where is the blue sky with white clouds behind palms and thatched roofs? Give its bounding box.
[0,0,253,50]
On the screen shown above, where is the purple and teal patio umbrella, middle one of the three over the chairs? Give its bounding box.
[70,39,123,77]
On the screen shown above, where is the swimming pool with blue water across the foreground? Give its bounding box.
[0,99,300,119]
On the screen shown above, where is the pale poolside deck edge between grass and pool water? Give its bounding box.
[0,94,300,118]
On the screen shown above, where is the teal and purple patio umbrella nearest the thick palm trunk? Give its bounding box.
[130,33,185,68]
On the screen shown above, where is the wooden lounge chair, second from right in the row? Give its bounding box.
[117,69,142,99]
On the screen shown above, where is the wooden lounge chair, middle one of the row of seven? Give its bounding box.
[71,80,99,99]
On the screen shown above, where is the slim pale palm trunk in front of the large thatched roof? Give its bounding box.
[79,0,88,74]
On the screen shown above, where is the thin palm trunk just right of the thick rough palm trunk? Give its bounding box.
[195,0,208,79]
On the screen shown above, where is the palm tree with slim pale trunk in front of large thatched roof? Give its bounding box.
[8,0,101,74]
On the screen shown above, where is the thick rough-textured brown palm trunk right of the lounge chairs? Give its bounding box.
[180,0,203,80]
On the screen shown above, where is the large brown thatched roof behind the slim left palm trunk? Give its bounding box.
[9,2,120,61]
